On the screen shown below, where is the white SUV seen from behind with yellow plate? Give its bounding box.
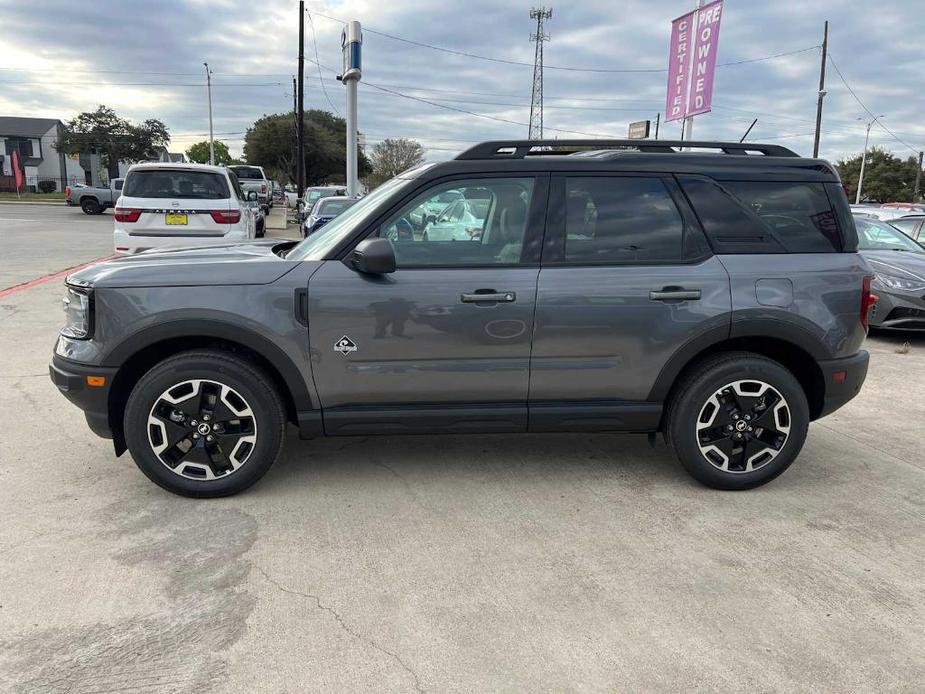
[113,163,257,255]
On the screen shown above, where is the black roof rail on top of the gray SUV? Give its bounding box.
[456,140,800,159]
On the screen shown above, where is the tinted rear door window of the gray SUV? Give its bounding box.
[564,176,684,263]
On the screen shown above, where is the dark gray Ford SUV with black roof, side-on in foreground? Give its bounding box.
[50,140,875,497]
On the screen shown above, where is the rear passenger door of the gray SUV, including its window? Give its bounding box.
[530,174,731,431]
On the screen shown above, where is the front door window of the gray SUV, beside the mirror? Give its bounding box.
[377,178,534,267]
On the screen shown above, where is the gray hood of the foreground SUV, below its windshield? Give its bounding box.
[67,239,299,288]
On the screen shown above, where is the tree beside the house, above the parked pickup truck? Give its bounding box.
[55,105,170,178]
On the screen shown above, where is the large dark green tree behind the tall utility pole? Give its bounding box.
[244,109,370,185]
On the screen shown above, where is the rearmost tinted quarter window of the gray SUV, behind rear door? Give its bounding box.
[679,176,844,253]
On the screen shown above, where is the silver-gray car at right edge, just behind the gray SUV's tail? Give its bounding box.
[854,217,925,330]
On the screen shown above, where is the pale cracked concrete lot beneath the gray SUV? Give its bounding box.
[0,205,925,694]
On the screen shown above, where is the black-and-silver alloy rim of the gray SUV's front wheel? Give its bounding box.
[146,378,257,482]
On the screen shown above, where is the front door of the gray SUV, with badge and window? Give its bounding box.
[308,176,547,434]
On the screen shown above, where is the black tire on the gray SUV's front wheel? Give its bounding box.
[123,350,286,498]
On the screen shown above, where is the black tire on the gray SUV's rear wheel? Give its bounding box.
[665,352,809,490]
